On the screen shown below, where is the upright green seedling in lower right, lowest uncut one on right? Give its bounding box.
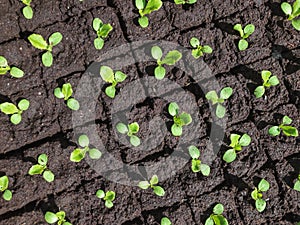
[251,179,270,212]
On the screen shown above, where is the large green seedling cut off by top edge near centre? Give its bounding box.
[135,0,162,28]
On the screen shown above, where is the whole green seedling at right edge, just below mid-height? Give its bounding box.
[269,116,299,137]
